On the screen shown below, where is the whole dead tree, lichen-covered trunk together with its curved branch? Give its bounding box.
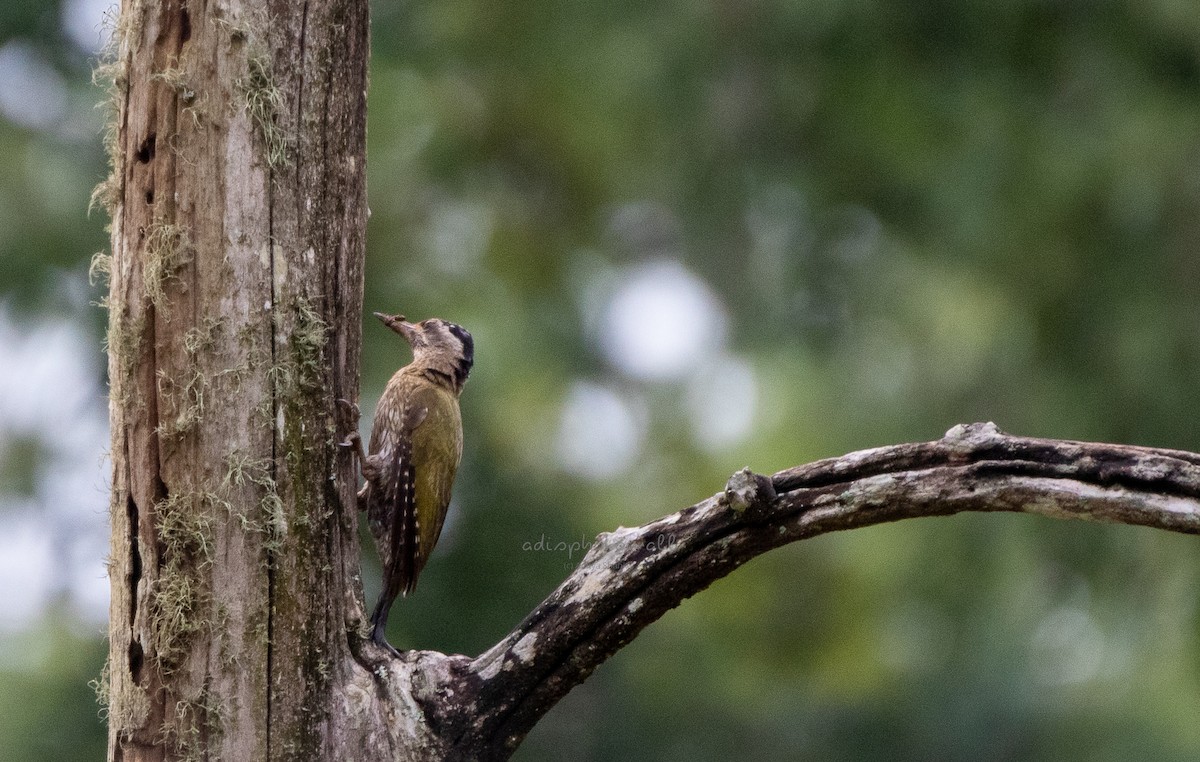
[98,0,1200,761]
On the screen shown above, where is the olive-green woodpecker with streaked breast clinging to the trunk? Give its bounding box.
[343,312,475,653]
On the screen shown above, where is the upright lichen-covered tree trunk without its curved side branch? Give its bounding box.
[101,0,386,760]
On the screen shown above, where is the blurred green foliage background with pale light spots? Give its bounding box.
[0,0,1200,761]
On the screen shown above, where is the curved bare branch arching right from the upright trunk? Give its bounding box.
[409,424,1200,760]
